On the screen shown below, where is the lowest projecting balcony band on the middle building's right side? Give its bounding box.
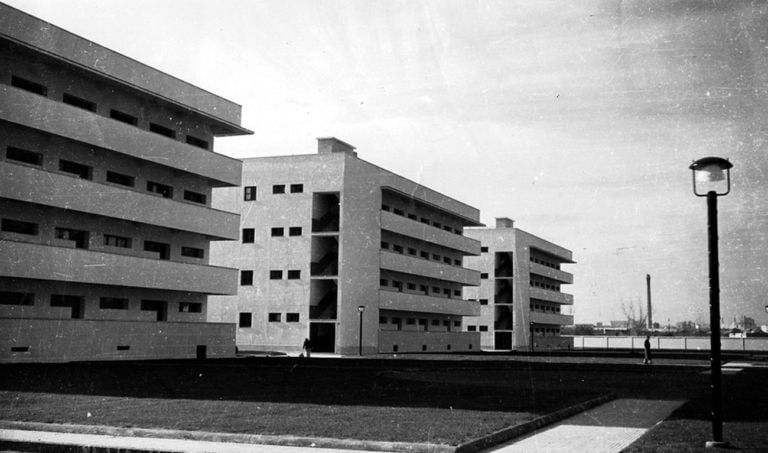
[379,290,480,316]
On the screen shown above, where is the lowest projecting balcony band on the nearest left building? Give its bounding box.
[0,241,237,295]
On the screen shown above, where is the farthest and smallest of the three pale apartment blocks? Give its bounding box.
[464,218,574,350]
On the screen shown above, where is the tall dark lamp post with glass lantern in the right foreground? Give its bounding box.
[688,157,733,448]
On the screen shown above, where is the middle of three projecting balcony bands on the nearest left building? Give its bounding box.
[0,161,240,240]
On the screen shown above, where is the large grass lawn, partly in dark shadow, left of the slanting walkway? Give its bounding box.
[0,358,706,445]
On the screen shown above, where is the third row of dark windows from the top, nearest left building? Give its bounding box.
[0,217,205,260]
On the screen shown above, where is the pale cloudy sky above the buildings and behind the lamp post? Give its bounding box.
[3,0,768,326]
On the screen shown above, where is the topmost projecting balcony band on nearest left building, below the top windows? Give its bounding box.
[0,85,242,186]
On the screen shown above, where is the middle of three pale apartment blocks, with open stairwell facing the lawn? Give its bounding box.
[208,138,481,354]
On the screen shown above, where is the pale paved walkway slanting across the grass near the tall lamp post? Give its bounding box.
[486,399,684,453]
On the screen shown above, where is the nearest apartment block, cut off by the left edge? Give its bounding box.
[0,4,249,361]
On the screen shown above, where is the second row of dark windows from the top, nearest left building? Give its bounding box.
[5,146,207,205]
